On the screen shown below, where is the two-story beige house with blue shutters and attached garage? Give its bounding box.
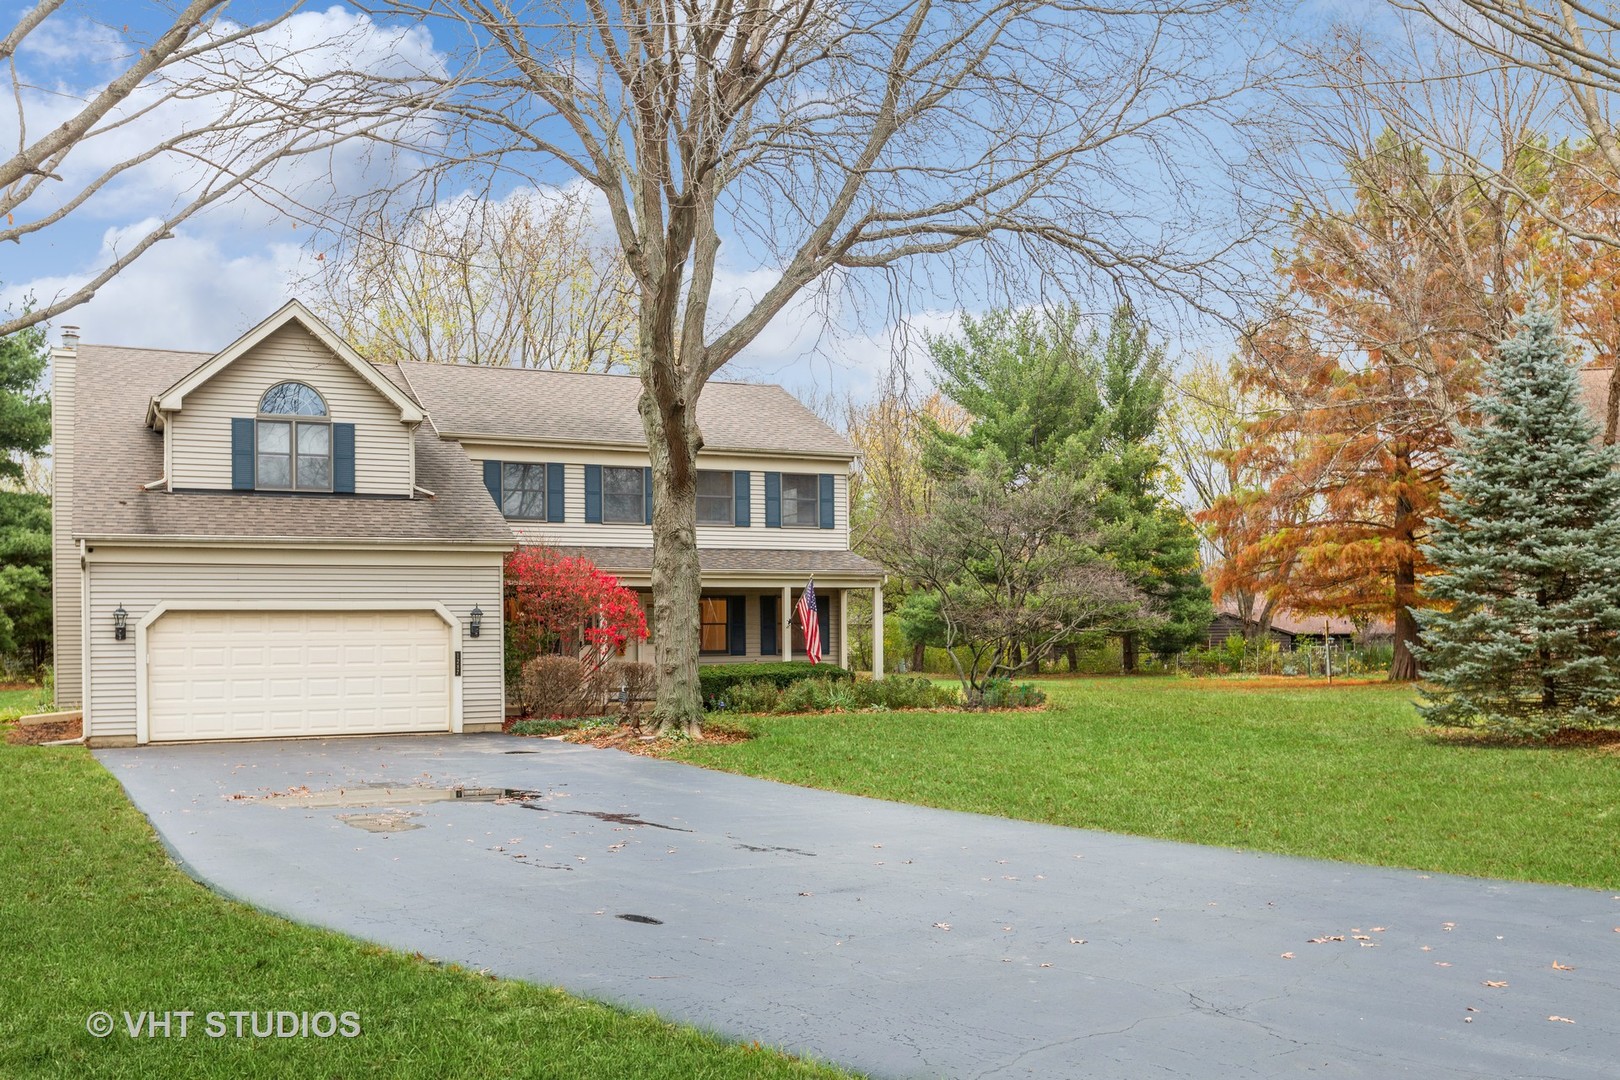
[52,301,883,745]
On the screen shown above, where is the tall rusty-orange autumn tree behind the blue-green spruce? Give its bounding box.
[1210,138,1529,680]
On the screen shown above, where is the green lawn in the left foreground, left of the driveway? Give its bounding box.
[0,746,846,1080]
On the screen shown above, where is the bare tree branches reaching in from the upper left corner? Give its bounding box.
[0,0,439,335]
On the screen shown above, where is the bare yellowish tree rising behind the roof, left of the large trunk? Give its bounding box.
[311,189,635,371]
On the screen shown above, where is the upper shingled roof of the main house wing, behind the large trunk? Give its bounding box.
[400,363,855,458]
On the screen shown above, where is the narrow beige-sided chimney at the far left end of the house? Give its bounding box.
[50,350,84,709]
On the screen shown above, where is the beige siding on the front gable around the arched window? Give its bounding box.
[165,322,411,495]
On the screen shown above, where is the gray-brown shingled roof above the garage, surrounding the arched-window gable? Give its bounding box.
[73,345,512,544]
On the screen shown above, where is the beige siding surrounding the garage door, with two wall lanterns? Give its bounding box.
[80,544,504,738]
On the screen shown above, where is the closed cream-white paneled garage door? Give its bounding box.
[146,610,452,742]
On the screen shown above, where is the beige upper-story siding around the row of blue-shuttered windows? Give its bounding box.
[467,445,849,551]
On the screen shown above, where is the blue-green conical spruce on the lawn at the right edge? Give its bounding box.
[1419,311,1620,738]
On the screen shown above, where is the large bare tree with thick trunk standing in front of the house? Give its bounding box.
[372,0,1267,732]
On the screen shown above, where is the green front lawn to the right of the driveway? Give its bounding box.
[671,678,1620,889]
